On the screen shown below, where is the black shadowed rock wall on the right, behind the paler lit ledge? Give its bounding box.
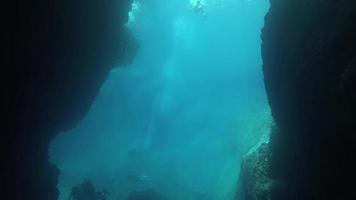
[262,0,356,200]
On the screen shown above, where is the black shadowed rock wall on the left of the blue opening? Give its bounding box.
[4,0,138,200]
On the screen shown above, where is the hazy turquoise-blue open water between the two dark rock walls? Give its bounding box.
[50,0,270,200]
